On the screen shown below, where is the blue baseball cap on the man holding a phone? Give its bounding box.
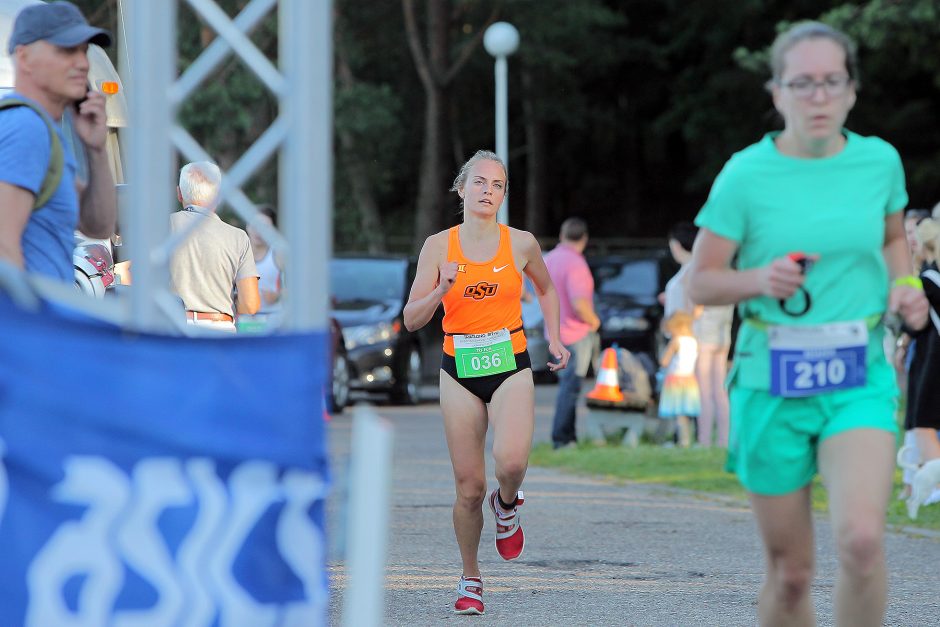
[7,0,111,54]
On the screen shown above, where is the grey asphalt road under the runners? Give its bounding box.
[329,386,940,627]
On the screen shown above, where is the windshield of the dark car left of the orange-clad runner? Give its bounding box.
[330,259,408,307]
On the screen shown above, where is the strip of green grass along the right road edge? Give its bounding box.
[529,443,940,531]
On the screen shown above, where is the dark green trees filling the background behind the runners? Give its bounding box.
[71,0,940,251]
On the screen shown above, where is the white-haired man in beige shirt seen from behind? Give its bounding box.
[170,161,261,332]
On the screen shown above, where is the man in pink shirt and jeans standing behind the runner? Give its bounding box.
[545,218,601,449]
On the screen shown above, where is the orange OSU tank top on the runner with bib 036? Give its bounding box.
[441,224,526,355]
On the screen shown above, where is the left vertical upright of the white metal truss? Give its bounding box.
[120,2,176,330]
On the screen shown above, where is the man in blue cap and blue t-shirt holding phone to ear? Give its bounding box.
[0,2,117,282]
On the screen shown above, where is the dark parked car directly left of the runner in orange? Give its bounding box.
[330,254,444,404]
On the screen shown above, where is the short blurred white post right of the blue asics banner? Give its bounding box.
[343,406,393,627]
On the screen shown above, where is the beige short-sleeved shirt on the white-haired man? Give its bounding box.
[170,207,258,317]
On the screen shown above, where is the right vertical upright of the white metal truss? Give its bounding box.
[279,0,333,330]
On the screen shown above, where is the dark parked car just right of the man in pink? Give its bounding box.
[588,248,679,363]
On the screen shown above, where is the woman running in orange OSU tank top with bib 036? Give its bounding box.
[404,150,568,614]
